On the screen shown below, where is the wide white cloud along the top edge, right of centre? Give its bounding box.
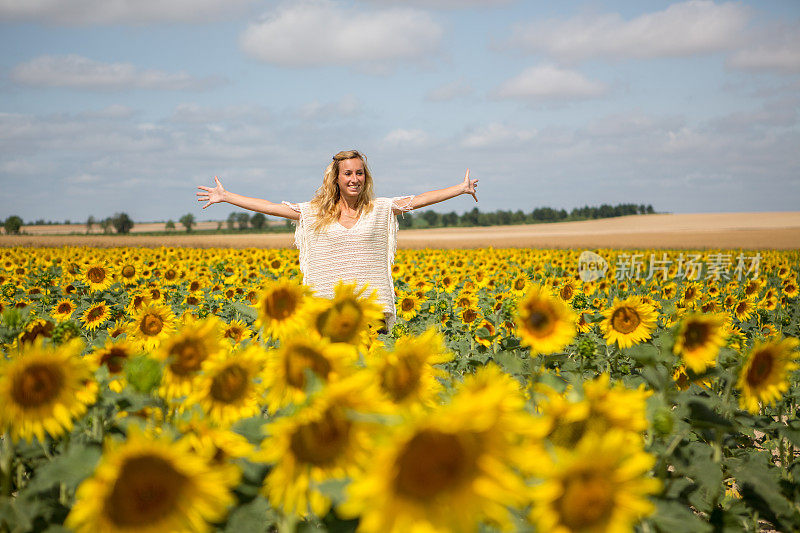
[510,0,748,60]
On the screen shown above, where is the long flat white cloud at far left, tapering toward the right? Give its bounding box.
[10,54,221,91]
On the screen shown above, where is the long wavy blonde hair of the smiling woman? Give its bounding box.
[311,150,375,232]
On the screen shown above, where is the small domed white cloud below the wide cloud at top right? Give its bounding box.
[495,64,607,101]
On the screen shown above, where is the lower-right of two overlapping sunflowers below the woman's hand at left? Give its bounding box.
[186,344,266,426]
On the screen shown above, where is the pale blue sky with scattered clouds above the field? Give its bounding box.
[0,0,800,222]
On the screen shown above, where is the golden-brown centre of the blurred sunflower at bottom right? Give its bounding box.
[556,472,614,531]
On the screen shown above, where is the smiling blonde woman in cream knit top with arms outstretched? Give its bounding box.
[197,150,478,327]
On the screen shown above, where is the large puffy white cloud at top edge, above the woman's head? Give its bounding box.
[240,0,442,67]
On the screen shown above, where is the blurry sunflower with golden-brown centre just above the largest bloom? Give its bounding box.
[372,328,453,405]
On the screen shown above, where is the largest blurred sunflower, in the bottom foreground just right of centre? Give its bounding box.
[338,370,532,533]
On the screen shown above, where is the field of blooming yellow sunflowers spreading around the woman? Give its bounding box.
[0,247,800,533]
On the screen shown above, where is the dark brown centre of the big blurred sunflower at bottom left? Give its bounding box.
[105,455,189,528]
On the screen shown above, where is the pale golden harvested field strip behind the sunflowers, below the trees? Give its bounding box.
[0,211,800,249]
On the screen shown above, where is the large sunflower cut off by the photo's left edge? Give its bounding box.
[0,338,97,442]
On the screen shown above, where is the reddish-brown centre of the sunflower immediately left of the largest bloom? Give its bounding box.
[291,409,351,466]
